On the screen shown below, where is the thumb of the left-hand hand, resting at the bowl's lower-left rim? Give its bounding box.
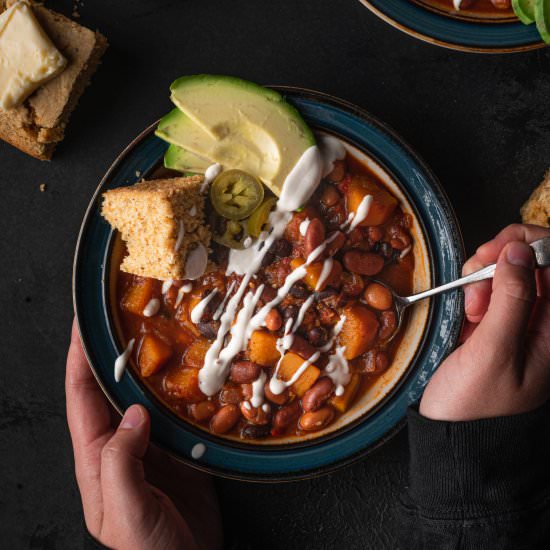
[101,405,151,517]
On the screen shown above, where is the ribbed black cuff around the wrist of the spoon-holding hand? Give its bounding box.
[408,402,550,519]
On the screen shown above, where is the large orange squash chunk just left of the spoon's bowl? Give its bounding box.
[339,303,379,361]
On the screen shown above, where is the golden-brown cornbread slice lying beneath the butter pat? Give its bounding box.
[0,0,108,160]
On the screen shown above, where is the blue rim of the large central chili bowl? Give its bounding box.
[73,86,464,482]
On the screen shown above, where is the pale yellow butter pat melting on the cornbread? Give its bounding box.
[0,2,67,110]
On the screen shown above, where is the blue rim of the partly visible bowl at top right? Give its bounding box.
[359,0,545,53]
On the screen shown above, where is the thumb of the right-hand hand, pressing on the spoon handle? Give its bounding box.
[476,241,537,357]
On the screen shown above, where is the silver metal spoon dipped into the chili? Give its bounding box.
[382,237,550,342]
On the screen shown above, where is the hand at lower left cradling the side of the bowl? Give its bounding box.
[65,323,221,550]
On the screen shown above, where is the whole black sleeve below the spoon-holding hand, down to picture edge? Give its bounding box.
[398,403,550,550]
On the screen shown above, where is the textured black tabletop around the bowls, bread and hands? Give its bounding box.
[0,0,550,550]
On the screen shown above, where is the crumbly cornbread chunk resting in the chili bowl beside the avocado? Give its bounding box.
[102,176,211,281]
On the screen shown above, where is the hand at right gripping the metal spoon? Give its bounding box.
[420,225,550,421]
